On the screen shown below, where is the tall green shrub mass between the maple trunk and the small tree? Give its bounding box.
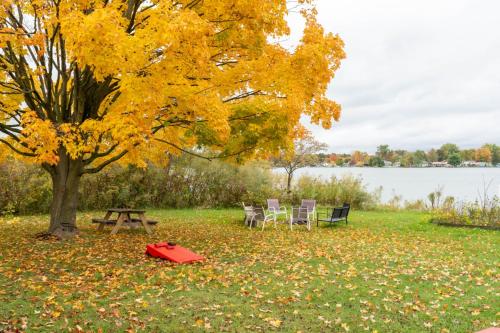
[80,156,272,210]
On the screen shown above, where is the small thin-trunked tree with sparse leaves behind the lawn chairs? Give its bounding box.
[272,135,328,194]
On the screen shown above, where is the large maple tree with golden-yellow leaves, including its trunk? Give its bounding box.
[0,0,345,237]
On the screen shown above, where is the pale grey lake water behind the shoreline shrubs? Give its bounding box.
[280,167,500,202]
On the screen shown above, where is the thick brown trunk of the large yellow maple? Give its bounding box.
[48,149,82,239]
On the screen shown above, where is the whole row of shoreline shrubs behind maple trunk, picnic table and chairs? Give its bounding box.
[0,156,379,215]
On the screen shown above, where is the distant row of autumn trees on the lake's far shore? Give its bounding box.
[316,143,500,167]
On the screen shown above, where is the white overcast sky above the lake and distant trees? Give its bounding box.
[286,0,500,152]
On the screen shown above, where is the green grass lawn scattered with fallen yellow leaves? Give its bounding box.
[0,210,500,333]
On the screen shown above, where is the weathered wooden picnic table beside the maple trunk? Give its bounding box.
[92,208,158,235]
